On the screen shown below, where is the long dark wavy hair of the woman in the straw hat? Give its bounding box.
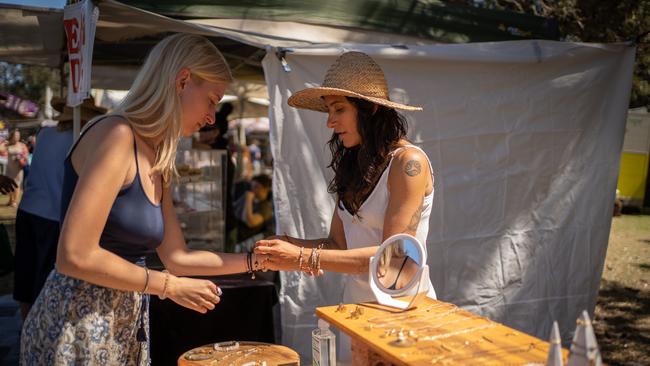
[328,97,408,216]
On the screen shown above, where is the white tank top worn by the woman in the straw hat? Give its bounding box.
[337,145,434,304]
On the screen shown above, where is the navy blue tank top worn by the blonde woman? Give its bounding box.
[61,119,164,263]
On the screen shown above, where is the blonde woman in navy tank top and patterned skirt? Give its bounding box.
[20,34,268,365]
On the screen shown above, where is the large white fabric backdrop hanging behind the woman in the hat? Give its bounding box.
[263,41,634,359]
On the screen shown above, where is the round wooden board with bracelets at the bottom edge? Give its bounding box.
[178,342,300,366]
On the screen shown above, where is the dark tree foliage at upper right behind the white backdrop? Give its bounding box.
[464,0,650,109]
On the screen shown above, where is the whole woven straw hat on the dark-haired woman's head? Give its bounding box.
[288,52,422,112]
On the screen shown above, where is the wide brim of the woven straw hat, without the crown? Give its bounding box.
[287,86,422,113]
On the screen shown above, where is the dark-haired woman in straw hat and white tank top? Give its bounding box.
[255,52,435,302]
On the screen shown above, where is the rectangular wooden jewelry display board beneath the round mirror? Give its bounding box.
[316,298,568,365]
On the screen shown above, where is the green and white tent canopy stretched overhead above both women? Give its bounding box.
[0,0,557,90]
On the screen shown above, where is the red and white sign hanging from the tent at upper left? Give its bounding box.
[63,0,99,107]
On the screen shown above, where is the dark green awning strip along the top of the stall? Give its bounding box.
[122,0,559,43]
